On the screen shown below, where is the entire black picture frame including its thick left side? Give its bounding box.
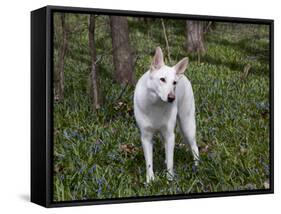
[31,6,274,207]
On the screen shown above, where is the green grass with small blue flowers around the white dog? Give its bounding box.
[53,17,269,201]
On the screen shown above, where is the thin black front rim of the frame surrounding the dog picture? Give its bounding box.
[31,5,274,208]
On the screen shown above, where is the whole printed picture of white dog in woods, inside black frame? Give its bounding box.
[51,12,271,202]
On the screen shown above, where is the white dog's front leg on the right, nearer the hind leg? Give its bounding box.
[162,131,175,180]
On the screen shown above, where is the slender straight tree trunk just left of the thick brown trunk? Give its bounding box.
[89,15,100,111]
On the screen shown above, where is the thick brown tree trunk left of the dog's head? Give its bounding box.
[110,16,135,84]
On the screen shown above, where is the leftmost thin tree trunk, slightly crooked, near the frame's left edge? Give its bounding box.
[56,14,68,100]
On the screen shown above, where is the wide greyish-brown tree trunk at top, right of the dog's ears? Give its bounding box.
[186,21,206,57]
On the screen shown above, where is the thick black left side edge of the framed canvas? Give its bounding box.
[30,8,48,206]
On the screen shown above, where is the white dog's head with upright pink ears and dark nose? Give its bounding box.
[149,47,188,102]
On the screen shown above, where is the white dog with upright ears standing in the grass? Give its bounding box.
[134,47,199,183]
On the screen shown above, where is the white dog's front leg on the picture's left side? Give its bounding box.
[141,131,154,183]
